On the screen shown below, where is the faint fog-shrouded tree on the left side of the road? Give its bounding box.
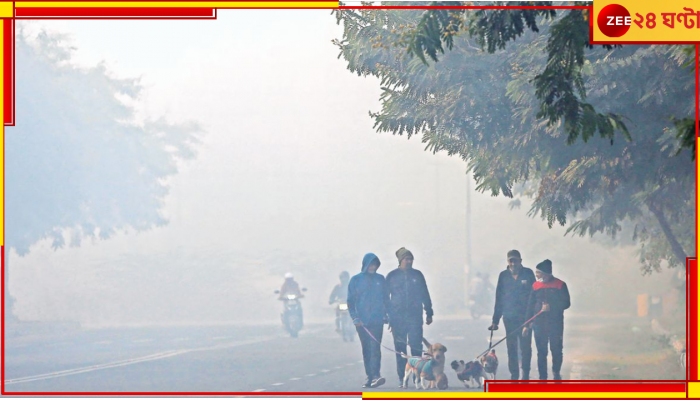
[5,29,200,315]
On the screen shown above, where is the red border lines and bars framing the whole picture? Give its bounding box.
[0,0,700,398]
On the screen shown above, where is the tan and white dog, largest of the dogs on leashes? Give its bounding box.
[403,338,448,390]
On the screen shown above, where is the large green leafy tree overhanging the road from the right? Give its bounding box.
[335,2,695,272]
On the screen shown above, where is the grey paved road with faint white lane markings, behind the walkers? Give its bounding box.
[5,319,556,394]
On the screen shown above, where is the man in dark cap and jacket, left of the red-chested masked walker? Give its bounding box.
[489,250,535,380]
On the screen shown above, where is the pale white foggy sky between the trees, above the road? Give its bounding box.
[6,10,680,325]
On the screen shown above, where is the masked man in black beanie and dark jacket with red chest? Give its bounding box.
[523,260,571,381]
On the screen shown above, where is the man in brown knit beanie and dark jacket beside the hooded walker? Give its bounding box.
[386,247,433,387]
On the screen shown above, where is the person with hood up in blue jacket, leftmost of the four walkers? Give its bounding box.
[348,253,389,388]
